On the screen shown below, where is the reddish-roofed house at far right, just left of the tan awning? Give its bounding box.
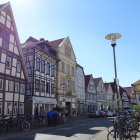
[123,87,138,108]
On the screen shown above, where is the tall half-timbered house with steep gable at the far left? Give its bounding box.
[0,2,26,117]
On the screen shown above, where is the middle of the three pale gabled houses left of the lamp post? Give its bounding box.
[94,77,106,110]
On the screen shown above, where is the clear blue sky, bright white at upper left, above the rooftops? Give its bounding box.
[0,0,140,87]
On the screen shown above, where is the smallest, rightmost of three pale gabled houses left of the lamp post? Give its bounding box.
[104,83,114,110]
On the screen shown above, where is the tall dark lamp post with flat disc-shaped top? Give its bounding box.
[105,33,122,140]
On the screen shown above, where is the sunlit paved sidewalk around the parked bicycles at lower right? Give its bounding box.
[91,128,140,140]
